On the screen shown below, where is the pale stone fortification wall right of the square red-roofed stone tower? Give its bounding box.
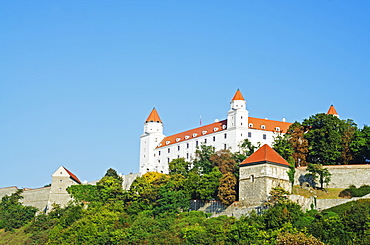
[294,164,370,188]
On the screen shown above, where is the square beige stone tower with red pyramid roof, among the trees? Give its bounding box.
[239,144,291,206]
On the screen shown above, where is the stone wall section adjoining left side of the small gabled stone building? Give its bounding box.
[21,187,51,211]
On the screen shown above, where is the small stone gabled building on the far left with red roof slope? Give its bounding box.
[48,166,81,209]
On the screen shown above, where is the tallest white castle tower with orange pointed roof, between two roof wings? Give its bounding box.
[227,89,249,151]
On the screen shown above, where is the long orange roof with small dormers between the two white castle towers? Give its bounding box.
[157,120,227,148]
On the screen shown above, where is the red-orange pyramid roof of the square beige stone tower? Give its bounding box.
[240,144,290,166]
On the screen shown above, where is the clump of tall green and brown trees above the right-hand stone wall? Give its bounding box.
[273,113,370,167]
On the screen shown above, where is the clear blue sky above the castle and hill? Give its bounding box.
[0,0,370,188]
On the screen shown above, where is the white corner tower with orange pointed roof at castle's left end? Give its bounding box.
[139,108,167,174]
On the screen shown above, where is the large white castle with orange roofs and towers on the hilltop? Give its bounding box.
[140,90,291,174]
